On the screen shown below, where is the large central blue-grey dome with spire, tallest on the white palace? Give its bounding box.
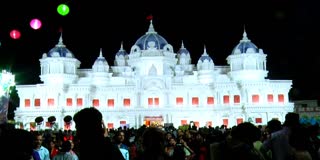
[135,20,168,50]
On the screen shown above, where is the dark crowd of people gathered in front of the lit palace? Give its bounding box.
[0,107,320,160]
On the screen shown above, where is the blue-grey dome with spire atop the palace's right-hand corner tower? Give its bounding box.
[231,31,259,55]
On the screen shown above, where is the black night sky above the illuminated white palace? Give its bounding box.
[0,0,320,99]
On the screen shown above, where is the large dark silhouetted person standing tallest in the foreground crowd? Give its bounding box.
[73,107,124,160]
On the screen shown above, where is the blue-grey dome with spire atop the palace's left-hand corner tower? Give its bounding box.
[47,35,74,58]
